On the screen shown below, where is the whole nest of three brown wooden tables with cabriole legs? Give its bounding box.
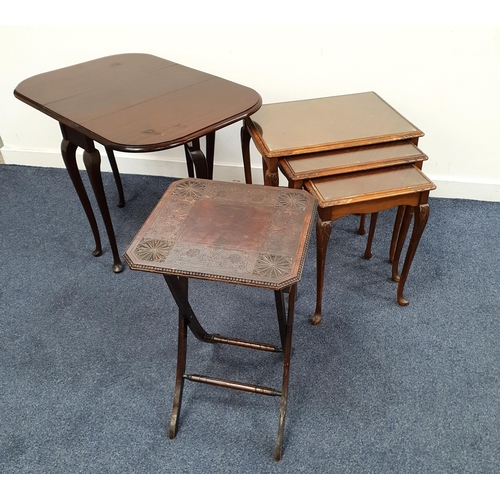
[241,92,436,325]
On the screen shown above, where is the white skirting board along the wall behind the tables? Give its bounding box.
[1,147,500,202]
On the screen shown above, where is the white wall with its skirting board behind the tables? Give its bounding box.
[0,2,500,201]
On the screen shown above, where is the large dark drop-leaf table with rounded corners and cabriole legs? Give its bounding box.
[14,54,262,272]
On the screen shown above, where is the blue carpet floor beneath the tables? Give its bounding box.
[0,165,500,474]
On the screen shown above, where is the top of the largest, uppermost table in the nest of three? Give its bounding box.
[245,92,424,158]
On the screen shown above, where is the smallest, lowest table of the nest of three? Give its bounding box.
[305,165,436,325]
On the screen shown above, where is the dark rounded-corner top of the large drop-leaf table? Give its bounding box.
[14,54,262,152]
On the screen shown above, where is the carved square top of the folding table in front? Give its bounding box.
[125,179,316,290]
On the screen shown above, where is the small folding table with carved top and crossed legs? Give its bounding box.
[125,179,316,460]
